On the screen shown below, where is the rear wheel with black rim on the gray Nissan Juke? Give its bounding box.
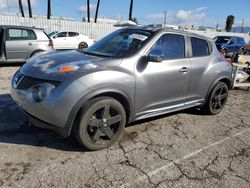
[204,82,228,115]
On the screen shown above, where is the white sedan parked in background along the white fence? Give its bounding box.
[49,31,94,49]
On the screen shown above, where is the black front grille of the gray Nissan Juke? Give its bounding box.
[13,71,61,89]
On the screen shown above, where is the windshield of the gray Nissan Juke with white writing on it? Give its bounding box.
[84,29,152,58]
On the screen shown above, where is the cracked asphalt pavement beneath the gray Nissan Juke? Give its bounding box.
[0,66,250,188]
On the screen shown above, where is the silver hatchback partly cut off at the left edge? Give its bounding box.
[0,25,53,63]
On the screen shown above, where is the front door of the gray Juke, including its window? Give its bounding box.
[135,34,190,116]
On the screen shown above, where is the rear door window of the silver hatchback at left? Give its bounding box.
[7,29,36,40]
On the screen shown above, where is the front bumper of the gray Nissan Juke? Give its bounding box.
[10,71,89,136]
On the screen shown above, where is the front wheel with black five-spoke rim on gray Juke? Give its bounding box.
[73,97,126,150]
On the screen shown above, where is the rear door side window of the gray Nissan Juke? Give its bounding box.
[191,37,209,57]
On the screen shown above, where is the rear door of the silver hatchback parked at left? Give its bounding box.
[5,28,37,61]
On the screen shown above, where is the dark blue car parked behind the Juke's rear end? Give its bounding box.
[213,36,246,55]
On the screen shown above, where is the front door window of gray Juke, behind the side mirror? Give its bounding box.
[153,34,185,60]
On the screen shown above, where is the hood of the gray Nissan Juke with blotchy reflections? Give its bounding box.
[21,50,121,80]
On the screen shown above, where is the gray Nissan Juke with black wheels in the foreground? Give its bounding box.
[11,27,232,150]
